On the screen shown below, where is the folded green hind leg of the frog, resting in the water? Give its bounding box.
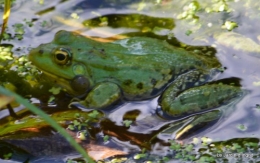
[160,80,243,117]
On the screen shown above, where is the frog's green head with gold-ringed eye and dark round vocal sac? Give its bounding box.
[29,31,91,95]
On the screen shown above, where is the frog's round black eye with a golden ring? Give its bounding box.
[54,48,71,65]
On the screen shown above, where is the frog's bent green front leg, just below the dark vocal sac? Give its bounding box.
[80,82,122,109]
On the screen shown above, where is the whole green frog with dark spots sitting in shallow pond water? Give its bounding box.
[29,31,242,139]
